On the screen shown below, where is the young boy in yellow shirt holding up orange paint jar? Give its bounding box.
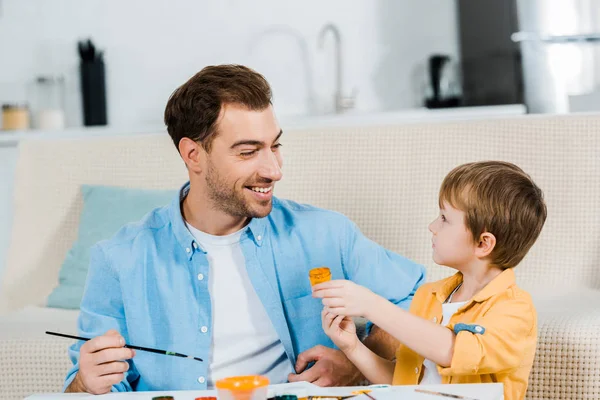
[313,161,546,400]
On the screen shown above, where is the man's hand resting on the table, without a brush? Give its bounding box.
[288,346,364,386]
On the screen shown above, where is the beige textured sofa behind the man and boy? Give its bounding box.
[0,115,600,399]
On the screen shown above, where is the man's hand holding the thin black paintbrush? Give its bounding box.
[65,330,135,394]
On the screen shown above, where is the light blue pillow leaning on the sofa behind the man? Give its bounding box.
[47,185,177,309]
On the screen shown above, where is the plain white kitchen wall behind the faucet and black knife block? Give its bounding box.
[0,0,458,128]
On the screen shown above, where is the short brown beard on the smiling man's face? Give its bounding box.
[206,161,271,218]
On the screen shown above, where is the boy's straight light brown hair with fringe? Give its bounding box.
[439,161,547,269]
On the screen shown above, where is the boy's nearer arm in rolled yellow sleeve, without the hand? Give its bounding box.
[369,296,536,375]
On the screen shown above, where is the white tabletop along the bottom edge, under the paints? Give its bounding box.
[26,382,504,400]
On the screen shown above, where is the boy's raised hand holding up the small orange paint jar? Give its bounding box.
[313,280,377,318]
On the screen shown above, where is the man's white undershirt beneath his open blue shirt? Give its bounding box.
[186,223,293,388]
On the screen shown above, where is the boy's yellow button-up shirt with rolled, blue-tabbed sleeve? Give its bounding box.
[393,269,537,400]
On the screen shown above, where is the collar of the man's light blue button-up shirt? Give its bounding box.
[169,181,267,259]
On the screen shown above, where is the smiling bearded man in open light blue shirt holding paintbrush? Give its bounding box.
[65,65,424,394]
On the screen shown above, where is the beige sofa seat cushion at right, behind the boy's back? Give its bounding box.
[528,290,600,400]
